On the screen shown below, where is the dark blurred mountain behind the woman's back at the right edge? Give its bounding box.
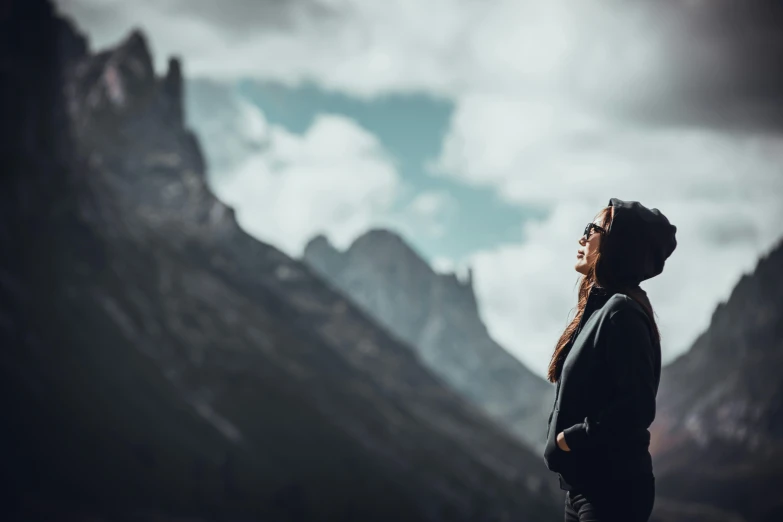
[651,242,783,522]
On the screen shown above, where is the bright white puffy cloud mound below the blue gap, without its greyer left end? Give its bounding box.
[225,115,400,255]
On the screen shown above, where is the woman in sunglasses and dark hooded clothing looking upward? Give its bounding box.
[544,198,677,522]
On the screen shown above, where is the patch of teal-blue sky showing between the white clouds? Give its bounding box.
[237,80,545,260]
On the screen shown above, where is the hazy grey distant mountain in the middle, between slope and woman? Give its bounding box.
[304,230,554,451]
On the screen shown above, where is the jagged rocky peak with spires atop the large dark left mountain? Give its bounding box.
[65,25,208,219]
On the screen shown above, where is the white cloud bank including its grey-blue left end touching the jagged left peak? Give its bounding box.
[188,84,404,256]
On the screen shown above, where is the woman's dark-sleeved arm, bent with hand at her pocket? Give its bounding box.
[562,308,657,451]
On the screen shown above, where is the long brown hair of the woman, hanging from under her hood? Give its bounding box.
[547,207,661,382]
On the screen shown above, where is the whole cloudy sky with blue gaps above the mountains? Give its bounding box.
[57,0,783,376]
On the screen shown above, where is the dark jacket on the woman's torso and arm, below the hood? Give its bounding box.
[544,288,661,489]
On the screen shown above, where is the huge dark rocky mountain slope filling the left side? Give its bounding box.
[0,0,561,521]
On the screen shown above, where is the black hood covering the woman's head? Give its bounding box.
[596,198,677,286]
